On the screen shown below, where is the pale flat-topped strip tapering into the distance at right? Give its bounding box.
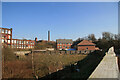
[88,47,120,80]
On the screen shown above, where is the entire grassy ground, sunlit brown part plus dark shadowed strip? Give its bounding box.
[2,49,104,80]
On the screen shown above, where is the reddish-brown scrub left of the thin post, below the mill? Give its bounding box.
[2,47,33,78]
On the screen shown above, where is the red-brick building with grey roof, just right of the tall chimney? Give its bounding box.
[56,39,73,50]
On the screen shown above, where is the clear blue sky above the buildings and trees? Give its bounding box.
[2,2,118,41]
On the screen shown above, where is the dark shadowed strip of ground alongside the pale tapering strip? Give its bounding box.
[40,51,105,80]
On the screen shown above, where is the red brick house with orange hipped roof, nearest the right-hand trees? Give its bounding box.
[77,40,96,51]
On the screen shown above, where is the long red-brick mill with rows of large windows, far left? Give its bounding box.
[0,28,35,49]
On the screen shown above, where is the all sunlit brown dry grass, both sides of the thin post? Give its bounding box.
[3,48,86,78]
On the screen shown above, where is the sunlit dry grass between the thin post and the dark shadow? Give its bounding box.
[34,54,86,77]
